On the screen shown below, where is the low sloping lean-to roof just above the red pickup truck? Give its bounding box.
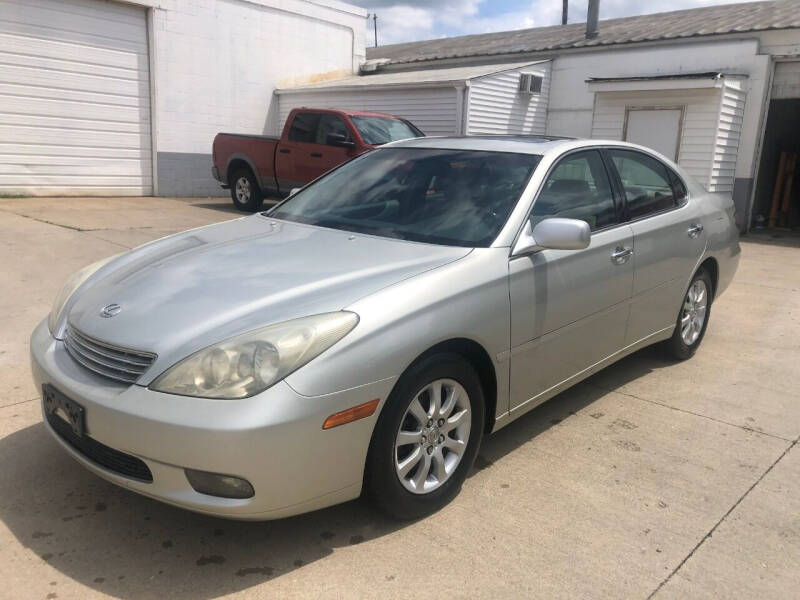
[275,60,548,94]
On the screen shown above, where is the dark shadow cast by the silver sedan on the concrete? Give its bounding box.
[0,349,669,598]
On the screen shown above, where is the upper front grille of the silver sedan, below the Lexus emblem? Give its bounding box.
[64,326,156,383]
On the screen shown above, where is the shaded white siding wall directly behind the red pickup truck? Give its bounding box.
[278,85,459,135]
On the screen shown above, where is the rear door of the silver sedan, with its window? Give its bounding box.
[606,148,706,344]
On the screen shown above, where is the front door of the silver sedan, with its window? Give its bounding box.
[509,149,633,411]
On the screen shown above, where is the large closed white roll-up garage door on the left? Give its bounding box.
[0,0,153,196]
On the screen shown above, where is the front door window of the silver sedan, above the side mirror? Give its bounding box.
[531,150,617,231]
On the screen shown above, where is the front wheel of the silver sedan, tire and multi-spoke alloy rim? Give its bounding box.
[365,353,485,519]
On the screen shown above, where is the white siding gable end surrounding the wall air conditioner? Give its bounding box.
[467,63,550,135]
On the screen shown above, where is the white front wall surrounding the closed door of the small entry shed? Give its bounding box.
[591,88,724,187]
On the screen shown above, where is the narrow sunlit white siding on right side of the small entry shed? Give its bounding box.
[708,79,747,193]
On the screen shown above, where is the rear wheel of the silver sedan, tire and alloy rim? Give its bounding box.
[665,269,714,360]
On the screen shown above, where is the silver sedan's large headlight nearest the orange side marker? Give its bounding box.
[150,311,358,399]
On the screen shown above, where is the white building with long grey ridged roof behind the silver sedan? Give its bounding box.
[277,0,800,230]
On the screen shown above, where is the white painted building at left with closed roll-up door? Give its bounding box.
[0,0,366,196]
